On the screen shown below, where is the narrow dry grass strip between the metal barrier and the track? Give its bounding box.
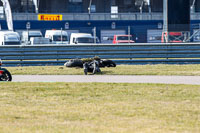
[8,65,200,76]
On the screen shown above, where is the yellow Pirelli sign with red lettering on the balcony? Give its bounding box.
[38,14,62,21]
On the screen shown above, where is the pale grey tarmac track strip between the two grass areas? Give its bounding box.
[13,75,200,85]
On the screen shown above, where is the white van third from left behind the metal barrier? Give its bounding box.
[45,30,69,44]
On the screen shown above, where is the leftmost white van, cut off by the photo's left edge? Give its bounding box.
[0,31,21,45]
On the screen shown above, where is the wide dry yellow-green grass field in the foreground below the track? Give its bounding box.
[0,82,200,133]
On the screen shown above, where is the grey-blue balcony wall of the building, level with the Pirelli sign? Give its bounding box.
[10,13,162,20]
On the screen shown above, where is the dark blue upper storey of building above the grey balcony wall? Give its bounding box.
[0,0,200,13]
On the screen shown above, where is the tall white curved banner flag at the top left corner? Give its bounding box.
[1,0,13,31]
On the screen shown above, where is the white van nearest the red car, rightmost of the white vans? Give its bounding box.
[70,33,99,44]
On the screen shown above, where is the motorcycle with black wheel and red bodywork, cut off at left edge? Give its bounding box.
[0,60,12,81]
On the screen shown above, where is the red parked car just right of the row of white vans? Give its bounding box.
[113,35,134,44]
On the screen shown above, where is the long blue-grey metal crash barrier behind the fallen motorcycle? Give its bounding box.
[0,43,200,66]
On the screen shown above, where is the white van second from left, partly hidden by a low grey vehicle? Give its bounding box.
[21,30,42,44]
